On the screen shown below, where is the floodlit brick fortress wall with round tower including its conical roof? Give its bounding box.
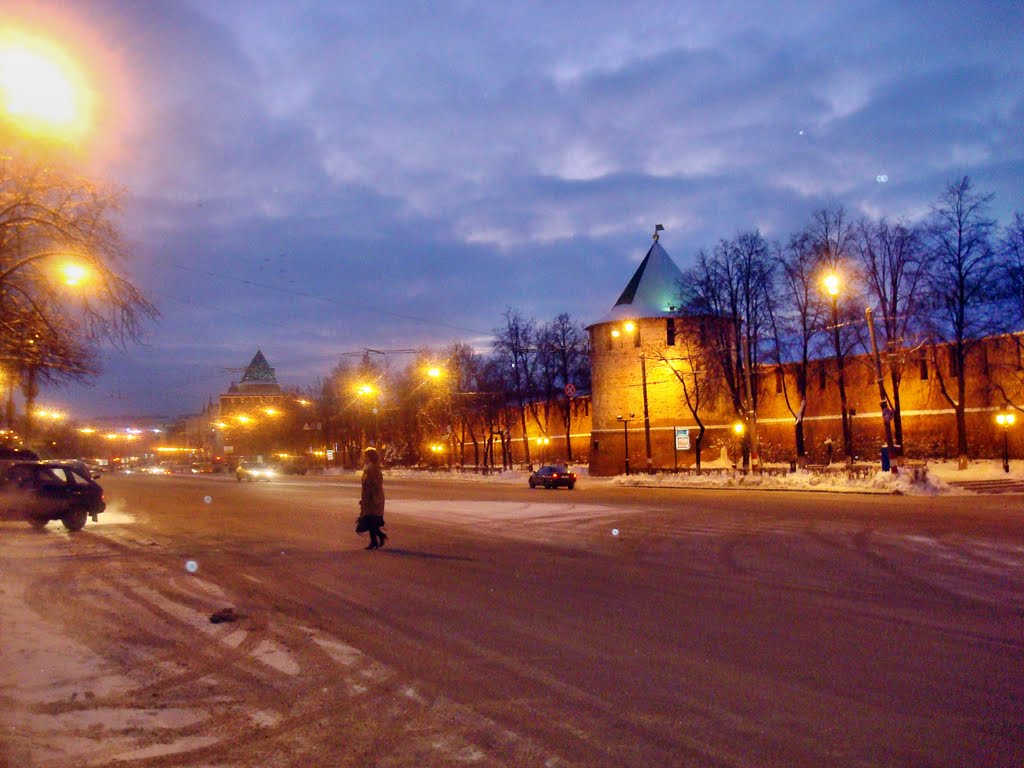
[588,238,1024,475]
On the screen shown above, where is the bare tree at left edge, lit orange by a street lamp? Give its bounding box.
[0,156,157,430]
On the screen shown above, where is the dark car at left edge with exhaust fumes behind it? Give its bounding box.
[0,461,106,530]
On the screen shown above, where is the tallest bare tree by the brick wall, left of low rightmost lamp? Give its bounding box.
[928,176,1002,467]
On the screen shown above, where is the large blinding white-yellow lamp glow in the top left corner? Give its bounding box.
[0,30,90,138]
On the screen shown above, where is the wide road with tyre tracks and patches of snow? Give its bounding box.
[0,476,1024,768]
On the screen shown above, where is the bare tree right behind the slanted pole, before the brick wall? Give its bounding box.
[856,218,926,445]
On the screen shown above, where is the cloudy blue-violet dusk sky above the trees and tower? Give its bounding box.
[0,0,1024,419]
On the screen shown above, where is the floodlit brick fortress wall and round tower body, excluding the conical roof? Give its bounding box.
[590,317,1024,475]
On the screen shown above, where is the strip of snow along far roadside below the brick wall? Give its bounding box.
[338,459,1024,496]
